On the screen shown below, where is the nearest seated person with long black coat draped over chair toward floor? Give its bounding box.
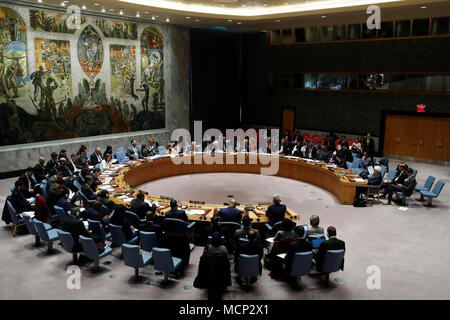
[194,232,231,301]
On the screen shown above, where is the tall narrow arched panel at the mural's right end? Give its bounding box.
[138,27,165,113]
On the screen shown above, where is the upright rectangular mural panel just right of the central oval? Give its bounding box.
[109,44,138,100]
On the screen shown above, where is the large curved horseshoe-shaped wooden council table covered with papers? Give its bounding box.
[100,154,367,223]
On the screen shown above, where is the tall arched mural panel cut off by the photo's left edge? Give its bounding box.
[0,7,29,102]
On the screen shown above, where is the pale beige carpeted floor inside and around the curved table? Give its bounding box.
[0,160,450,300]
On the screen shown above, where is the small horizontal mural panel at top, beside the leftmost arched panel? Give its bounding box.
[30,10,86,34]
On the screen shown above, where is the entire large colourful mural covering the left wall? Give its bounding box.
[0,7,165,145]
